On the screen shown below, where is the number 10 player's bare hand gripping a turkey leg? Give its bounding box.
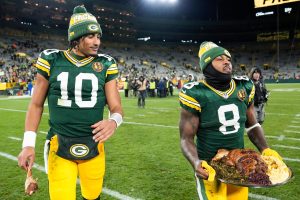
[18,147,35,171]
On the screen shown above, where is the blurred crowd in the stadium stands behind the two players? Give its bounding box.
[0,30,300,97]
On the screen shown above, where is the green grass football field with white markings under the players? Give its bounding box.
[0,84,300,200]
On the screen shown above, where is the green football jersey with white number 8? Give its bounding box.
[179,77,255,161]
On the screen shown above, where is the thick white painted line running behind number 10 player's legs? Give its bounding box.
[0,151,140,200]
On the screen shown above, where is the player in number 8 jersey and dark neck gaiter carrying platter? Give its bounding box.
[179,42,282,200]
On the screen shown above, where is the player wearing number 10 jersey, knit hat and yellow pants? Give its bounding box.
[18,6,123,200]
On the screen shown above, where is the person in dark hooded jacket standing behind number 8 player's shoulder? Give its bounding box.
[249,67,269,124]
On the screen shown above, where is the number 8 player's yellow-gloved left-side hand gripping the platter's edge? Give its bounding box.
[195,160,216,182]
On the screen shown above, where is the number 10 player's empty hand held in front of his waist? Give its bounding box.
[91,119,117,143]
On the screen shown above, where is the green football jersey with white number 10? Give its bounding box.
[35,49,118,139]
